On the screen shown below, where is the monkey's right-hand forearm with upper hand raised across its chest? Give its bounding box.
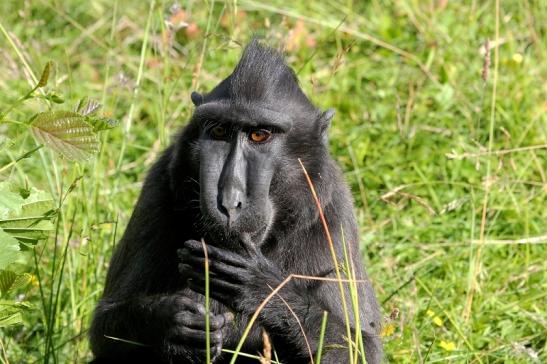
[178,240,378,363]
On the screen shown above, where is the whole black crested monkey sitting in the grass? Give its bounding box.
[90,40,382,363]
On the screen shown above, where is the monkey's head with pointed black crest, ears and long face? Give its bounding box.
[186,40,334,244]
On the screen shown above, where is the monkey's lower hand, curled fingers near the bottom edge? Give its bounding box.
[153,295,234,363]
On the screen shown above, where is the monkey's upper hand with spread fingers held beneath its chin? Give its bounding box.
[177,240,283,313]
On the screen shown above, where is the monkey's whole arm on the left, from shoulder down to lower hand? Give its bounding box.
[90,150,230,362]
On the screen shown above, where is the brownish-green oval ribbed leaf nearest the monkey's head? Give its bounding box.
[30,111,99,161]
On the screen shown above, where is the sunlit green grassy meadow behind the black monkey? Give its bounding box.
[0,0,547,363]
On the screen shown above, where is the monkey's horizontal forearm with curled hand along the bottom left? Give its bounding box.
[91,293,222,359]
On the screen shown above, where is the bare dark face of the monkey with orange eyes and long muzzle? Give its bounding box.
[199,114,284,244]
